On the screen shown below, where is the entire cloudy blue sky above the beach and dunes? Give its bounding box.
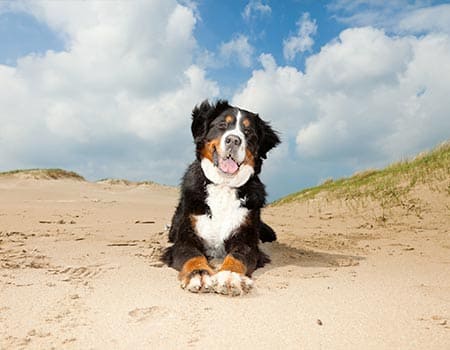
[0,0,450,200]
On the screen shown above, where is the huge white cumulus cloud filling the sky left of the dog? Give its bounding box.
[0,0,219,182]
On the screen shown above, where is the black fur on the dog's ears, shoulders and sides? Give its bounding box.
[162,100,280,276]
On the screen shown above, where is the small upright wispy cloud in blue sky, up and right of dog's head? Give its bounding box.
[283,13,317,61]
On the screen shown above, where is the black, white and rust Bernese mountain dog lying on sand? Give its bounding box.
[162,100,280,295]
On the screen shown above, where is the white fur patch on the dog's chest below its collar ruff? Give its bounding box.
[195,184,248,258]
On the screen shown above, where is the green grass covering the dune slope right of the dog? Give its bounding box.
[272,141,450,205]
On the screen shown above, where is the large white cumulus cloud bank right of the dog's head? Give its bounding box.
[234,27,450,196]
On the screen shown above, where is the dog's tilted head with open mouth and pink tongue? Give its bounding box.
[191,101,280,187]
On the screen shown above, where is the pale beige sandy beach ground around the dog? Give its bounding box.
[0,177,450,349]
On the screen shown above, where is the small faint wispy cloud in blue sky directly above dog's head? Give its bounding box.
[219,34,254,67]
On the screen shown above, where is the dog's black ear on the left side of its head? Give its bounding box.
[191,100,230,143]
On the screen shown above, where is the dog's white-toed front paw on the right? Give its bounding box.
[211,270,253,296]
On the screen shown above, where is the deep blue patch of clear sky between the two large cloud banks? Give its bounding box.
[195,0,345,93]
